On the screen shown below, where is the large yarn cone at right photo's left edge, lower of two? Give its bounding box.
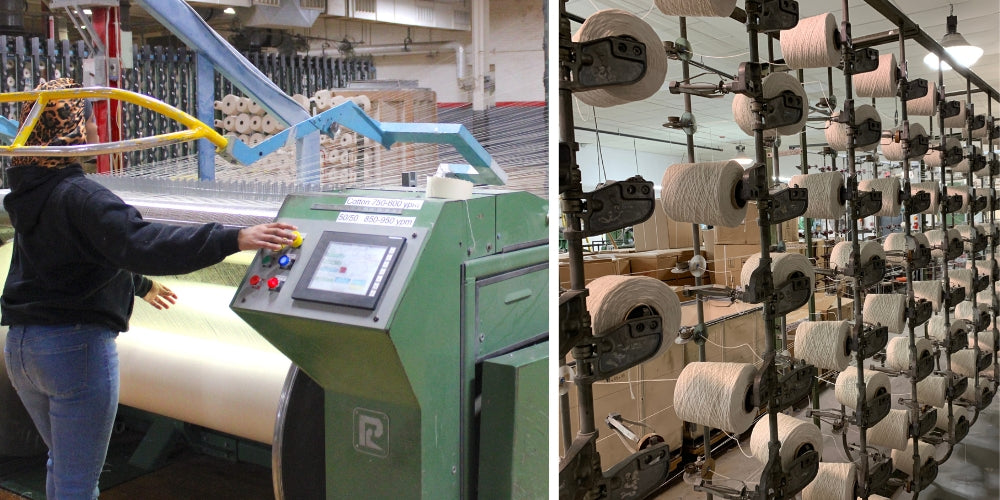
[587,276,681,355]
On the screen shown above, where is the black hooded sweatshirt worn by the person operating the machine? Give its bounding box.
[0,165,239,332]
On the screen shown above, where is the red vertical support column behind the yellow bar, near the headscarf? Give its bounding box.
[91,7,124,174]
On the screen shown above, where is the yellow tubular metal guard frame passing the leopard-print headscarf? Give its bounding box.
[0,87,229,156]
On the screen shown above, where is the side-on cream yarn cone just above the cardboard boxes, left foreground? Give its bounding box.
[660,160,747,227]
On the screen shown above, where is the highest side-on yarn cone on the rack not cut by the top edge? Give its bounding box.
[781,12,841,69]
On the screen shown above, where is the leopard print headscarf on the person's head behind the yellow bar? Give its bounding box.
[11,78,87,168]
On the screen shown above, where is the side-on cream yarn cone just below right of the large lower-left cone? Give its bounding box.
[674,361,757,434]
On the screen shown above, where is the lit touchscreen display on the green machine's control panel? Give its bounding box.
[308,241,389,295]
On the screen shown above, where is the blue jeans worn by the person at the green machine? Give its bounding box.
[4,325,118,500]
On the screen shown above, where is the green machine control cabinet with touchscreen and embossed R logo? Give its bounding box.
[231,189,548,500]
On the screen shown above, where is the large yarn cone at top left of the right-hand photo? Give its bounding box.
[573,9,667,108]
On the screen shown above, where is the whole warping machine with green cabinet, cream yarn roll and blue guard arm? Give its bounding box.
[0,63,548,499]
